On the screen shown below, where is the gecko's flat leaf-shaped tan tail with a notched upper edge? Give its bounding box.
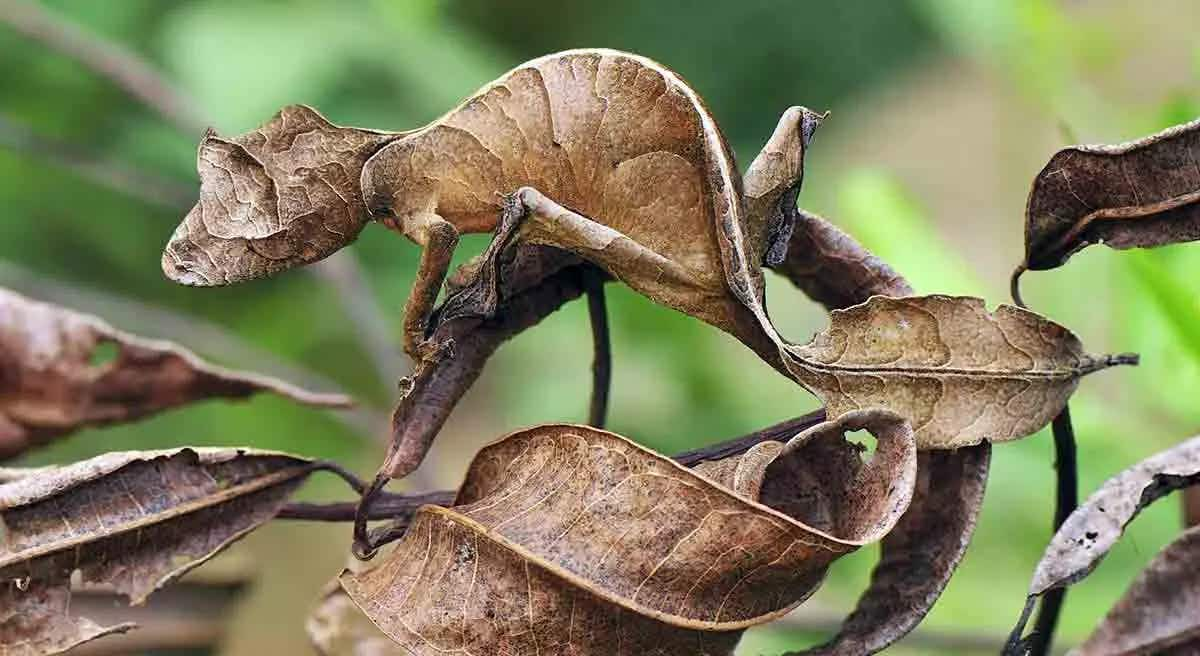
[785,295,1136,450]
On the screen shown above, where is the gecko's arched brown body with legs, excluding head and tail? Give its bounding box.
[362,50,816,356]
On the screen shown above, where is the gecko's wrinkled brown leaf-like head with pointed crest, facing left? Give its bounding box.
[162,106,398,285]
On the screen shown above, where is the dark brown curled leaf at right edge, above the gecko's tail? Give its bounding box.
[1019,115,1200,271]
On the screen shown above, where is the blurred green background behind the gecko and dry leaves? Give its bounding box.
[0,0,1200,655]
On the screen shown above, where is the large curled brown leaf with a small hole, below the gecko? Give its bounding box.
[342,410,916,656]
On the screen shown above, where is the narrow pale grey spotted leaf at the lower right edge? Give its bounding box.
[1030,437,1200,596]
